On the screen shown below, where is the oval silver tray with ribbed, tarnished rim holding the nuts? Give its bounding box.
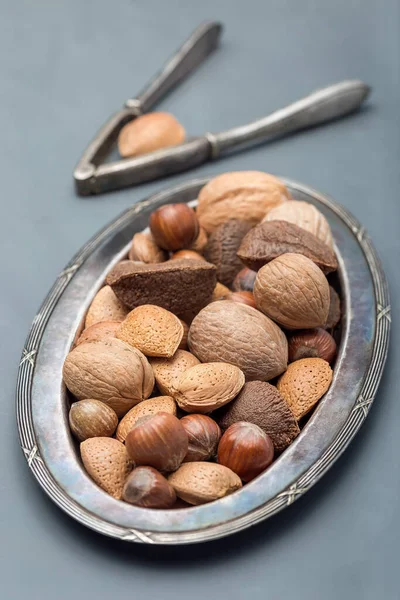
[17,180,390,544]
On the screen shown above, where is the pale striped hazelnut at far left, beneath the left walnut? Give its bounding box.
[69,400,118,442]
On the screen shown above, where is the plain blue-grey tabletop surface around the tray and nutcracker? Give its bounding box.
[0,0,400,600]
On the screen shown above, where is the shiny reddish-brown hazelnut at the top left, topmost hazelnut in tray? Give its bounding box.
[150,204,199,251]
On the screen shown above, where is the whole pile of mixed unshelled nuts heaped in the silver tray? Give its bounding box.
[63,172,340,508]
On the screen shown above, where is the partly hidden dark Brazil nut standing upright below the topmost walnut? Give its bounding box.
[204,219,251,286]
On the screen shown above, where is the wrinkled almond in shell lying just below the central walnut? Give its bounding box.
[174,362,244,413]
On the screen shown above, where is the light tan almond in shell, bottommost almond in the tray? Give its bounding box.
[168,462,242,505]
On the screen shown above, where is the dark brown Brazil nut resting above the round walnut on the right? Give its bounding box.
[238,221,337,273]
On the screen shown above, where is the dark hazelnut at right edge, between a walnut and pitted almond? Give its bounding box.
[288,327,336,363]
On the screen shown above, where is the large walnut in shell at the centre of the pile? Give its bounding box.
[189,300,288,381]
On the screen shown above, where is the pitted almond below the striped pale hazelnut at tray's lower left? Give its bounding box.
[80,437,132,500]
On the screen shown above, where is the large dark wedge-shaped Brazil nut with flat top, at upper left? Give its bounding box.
[107,260,217,315]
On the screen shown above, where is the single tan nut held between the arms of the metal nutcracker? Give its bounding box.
[118,112,185,158]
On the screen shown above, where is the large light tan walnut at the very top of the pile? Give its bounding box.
[197,171,289,233]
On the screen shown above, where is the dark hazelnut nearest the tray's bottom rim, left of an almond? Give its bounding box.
[122,467,176,508]
